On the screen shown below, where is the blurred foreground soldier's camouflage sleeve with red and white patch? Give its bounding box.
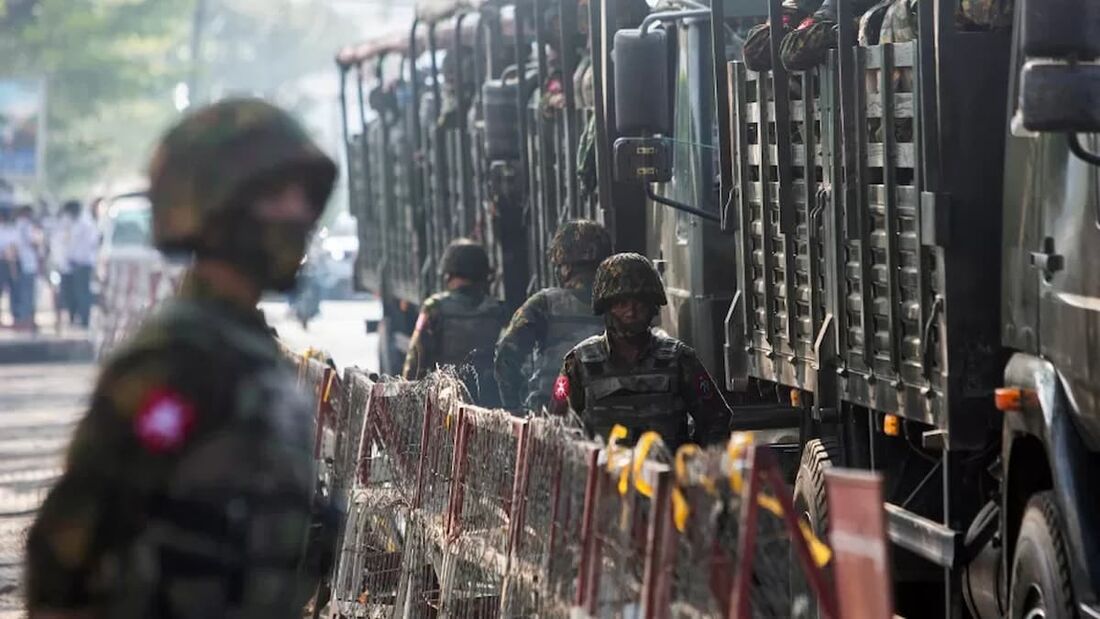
[25,351,212,611]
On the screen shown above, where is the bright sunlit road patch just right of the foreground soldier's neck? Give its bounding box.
[260,301,382,371]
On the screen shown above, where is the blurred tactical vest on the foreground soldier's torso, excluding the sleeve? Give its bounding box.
[106,301,331,619]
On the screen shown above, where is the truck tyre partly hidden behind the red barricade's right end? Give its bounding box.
[790,439,837,617]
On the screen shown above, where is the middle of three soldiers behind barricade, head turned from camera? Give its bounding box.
[496,220,612,410]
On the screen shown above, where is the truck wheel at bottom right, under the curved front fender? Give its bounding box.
[1009,490,1077,619]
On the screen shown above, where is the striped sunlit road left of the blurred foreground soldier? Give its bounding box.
[0,364,96,619]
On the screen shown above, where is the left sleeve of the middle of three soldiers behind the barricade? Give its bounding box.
[494,294,549,409]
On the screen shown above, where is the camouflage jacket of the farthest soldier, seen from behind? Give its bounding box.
[402,285,505,388]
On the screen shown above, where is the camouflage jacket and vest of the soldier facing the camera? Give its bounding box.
[551,333,733,450]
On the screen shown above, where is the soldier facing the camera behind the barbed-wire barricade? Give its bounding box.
[551,254,732,451]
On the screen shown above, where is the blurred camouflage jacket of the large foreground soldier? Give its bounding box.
[26,277,319,619]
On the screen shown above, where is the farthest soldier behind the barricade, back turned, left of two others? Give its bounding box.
[402,239,505,407]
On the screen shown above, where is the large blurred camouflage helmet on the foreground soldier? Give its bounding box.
[149,99,337,250]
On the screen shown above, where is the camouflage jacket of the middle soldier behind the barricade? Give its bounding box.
[495,274,604,409]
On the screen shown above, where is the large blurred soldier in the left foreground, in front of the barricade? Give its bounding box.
[26,99,338,619]
